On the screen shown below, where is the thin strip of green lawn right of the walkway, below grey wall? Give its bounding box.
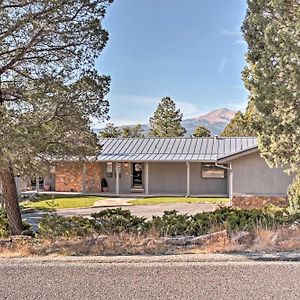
[128,197,229,205]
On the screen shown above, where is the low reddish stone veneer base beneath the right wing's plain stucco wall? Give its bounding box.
[231,195,289,209]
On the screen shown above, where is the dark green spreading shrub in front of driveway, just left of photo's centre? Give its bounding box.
[91,208,149,233]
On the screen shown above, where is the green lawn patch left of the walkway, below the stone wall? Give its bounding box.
[21,196,106,209]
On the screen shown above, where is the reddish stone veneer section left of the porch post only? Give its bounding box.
[55,162,83,192]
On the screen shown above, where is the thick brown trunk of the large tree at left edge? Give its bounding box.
[0,162,22,235]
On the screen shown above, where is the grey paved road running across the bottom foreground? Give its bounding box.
[0,255,300,300]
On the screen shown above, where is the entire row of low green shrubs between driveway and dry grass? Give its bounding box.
[35,208,300,238]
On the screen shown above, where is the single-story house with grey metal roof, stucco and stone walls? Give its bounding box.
[45,137,292,207]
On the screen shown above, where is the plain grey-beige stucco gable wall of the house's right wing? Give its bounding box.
[231,151,292,196]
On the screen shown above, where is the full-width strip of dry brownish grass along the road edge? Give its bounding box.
[0,226,300,257]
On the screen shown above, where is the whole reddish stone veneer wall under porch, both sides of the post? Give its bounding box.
[55,162,101,193]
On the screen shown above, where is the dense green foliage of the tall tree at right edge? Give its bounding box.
[243,0,300,171]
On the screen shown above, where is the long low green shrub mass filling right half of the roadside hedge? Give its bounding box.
[150,208,300,236]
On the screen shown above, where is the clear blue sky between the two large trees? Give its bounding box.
[97,0,247,125]
